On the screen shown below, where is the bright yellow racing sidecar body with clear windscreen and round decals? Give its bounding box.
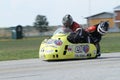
[39,28,97,60]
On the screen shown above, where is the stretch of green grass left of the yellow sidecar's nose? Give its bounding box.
[0,37,48,61]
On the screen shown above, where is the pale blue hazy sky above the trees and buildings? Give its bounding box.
[0,0,120,27]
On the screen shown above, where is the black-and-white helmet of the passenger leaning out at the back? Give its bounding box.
[97,22,109,35]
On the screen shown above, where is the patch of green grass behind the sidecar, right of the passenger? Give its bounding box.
[100,33,120,53]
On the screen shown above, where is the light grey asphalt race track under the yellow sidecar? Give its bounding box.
[0,53,120,80]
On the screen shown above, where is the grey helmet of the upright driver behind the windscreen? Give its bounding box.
[62,14,73,28]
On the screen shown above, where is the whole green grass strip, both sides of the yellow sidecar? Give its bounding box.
[0,33,120,61]
